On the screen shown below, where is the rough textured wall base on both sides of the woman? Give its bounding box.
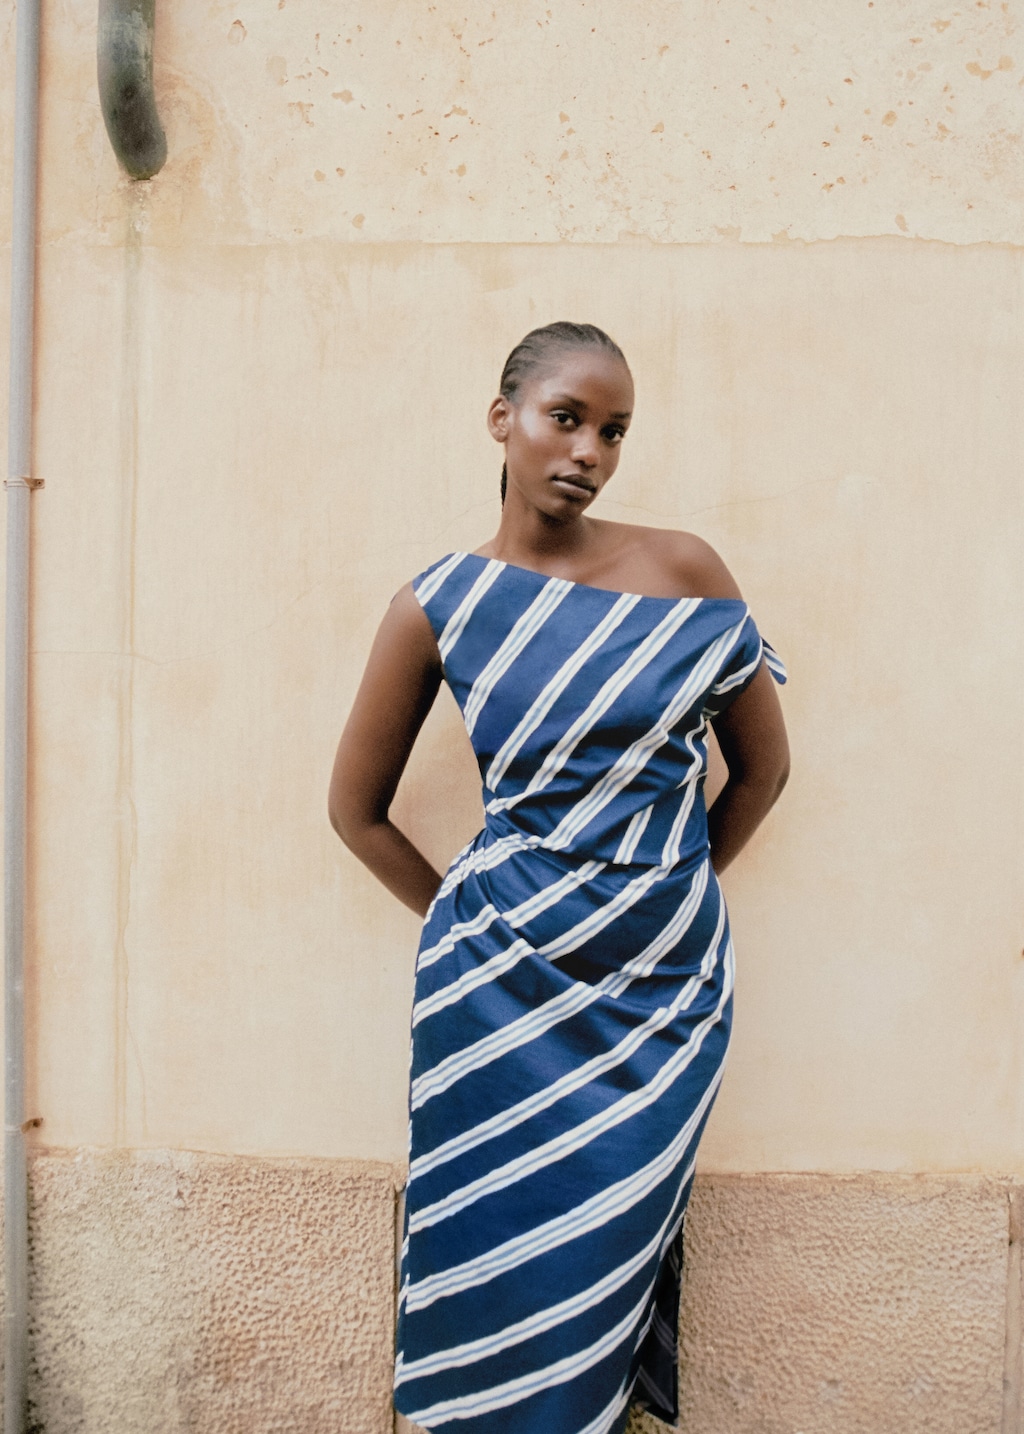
[6,1150,1024,1434]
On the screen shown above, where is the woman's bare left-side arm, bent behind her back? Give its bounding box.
[327,585,442,916]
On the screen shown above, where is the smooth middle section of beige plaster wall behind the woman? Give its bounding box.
[17,239,1024,1170]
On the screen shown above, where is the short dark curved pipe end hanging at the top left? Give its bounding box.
[96,0,168,179]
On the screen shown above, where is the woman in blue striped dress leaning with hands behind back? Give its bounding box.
[330,323,789,1434]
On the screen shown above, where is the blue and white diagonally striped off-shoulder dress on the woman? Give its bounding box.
[394,552,784,1434]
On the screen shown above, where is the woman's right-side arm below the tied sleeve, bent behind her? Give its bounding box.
[707,663,789,872]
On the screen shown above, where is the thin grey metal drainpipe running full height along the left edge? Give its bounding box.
[3,0,40,1434]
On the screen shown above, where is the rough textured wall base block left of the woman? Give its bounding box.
[24,1152,394,1434]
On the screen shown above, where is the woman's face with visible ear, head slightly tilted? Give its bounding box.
[488,348,632,519]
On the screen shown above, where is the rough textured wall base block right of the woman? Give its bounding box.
[680,1174,1021,1434]
